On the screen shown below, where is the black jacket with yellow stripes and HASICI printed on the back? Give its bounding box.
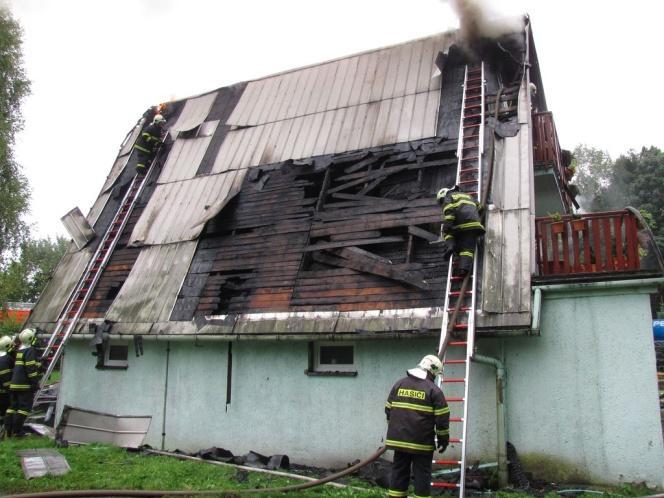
[385,373,450,453]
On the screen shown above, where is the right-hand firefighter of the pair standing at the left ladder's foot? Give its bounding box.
[5,329,41,437]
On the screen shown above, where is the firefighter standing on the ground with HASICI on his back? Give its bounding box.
[385,355,450,498]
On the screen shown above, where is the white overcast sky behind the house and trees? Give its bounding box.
[5,0,664,241]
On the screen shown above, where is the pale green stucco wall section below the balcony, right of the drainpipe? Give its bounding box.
[487,286,664,486]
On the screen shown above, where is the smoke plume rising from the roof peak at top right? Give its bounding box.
[442,0,523,44]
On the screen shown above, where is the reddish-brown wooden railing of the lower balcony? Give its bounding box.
[535,210,640,276]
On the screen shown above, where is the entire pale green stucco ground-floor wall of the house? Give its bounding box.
[61,288,664,485]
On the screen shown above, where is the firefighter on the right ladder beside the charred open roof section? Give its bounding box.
[436,185,484,277]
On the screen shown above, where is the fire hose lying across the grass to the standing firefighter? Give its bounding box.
[2,446,386,498]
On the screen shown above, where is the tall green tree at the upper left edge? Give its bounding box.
[0,7,30,267]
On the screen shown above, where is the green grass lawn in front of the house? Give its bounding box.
[0,435,654,498]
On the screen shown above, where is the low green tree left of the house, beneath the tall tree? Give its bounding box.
[0,237,69,303]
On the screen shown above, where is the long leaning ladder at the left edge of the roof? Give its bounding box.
[35,133,161,403]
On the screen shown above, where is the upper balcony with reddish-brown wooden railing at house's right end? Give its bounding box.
[532,111,574,213]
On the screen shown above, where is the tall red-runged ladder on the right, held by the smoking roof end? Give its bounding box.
[431,64,485,497]
